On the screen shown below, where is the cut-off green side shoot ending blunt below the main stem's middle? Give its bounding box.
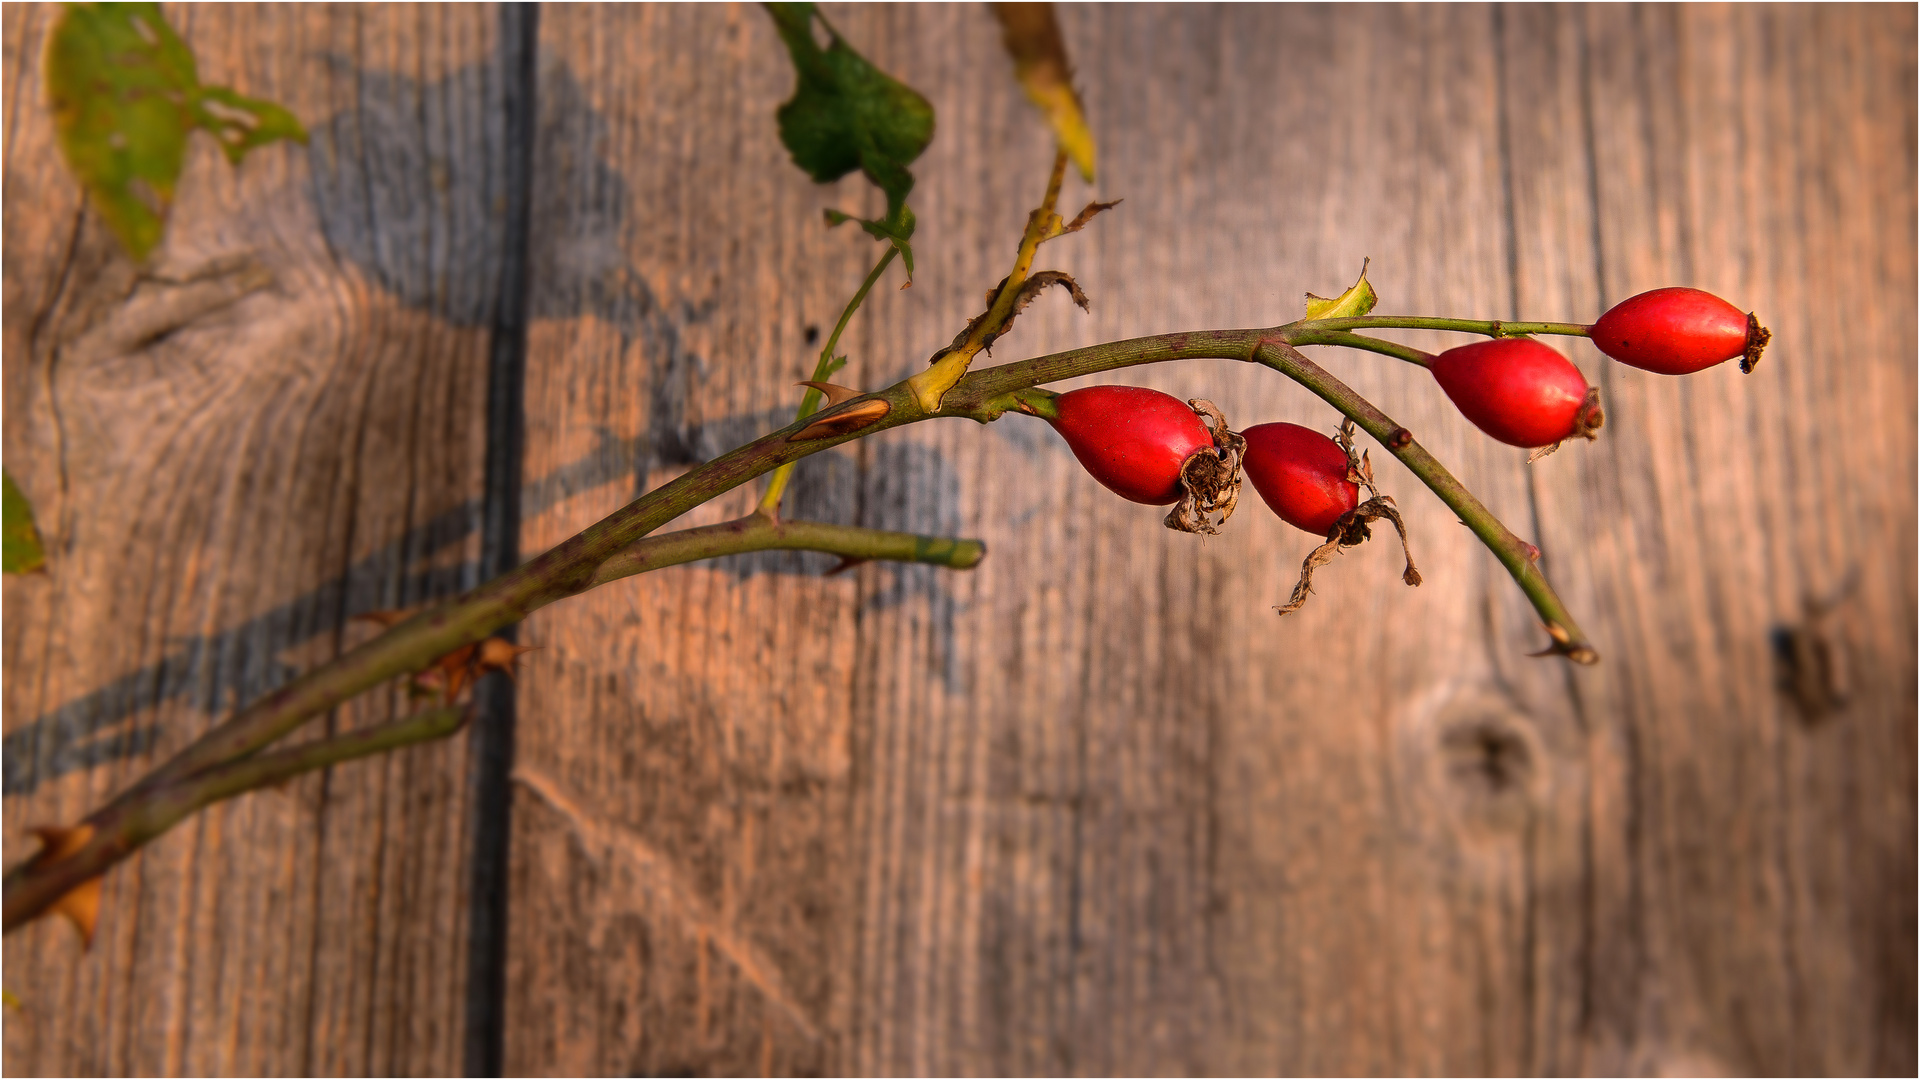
[593,513,987,586]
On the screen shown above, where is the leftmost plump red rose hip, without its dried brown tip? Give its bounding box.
[1050,386,1213,505]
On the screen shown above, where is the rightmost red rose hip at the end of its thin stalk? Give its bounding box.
[1594,288,1766,375]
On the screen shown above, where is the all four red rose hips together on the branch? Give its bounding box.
[1050,288,1768,609]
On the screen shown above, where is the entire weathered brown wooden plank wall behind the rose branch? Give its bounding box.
[4,4,1920,1074]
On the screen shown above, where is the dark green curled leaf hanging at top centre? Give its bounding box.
[766,4,933,226]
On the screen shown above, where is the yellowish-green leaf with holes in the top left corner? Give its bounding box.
[46,4,307,259]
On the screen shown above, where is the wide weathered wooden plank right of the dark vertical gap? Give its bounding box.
[507,6,1916,1074]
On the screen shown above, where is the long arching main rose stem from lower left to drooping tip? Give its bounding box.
[4,317,1594,930]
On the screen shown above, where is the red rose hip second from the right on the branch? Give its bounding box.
[1432,338,1599,446]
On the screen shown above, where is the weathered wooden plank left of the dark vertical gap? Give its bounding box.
[4,6,507,1074]
